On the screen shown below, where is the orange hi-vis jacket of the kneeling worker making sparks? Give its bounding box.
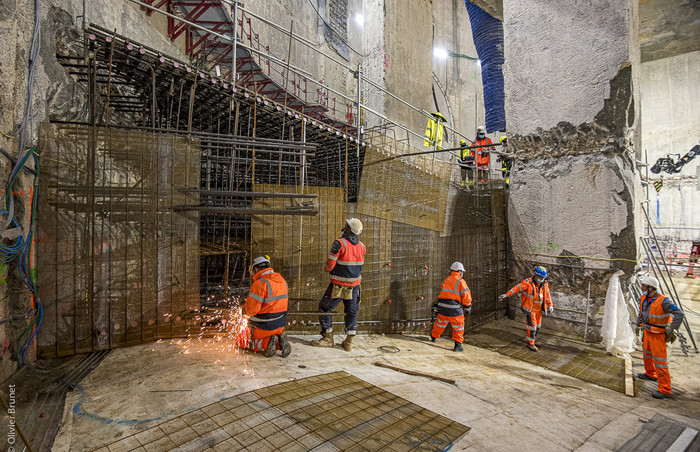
[243,267,289,330]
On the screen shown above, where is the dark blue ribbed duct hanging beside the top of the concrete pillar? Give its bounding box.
[464,0,506,132]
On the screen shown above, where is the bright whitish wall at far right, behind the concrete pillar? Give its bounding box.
[640,52,700,247]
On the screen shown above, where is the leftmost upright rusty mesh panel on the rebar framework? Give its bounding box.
[37,124,199,357]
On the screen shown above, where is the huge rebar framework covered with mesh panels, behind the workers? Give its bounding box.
[39,12,506,356]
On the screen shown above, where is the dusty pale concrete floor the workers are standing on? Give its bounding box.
[53,310,700,451]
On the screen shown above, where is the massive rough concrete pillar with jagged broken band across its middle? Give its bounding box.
[503,0,639,337]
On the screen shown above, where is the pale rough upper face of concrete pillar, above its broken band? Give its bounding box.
[503,0,639,134]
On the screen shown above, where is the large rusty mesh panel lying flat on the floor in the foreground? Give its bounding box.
[98,372,470,452]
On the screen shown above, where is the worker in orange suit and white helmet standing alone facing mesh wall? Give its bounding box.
[430,262,472,352]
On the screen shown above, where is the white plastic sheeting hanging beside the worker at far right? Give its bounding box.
[601,271,636,358]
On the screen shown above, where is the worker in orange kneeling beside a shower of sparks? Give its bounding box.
[243,256,292,358]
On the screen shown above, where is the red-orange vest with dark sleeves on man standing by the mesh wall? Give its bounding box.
[325,233,367,287]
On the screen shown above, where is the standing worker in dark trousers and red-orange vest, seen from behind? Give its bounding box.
[311,218,366,352]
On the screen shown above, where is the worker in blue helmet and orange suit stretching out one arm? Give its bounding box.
[499,265,554,352]
